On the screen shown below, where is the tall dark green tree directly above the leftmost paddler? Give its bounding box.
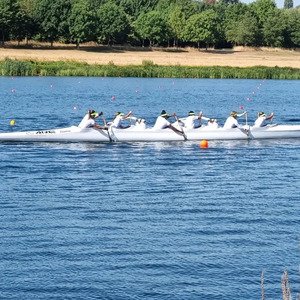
[69,0,96,48]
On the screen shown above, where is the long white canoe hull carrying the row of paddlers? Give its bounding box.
[0,125,300,143]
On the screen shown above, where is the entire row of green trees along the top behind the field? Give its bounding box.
[0,0,300,48]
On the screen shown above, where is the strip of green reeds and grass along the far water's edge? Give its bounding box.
[0,58,300,80]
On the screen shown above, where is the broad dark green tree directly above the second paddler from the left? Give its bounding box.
[96,1,129,44]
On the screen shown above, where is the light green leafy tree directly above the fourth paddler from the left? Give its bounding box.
[185,9,217,49]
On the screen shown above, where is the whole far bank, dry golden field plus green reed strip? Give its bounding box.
[0,45,300,79]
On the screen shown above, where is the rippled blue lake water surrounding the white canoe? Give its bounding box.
[0,77,300,300]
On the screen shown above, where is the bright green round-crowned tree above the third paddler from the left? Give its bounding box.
[133,10,169,47]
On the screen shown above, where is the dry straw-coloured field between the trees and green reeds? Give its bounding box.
[0,44,300,69]
